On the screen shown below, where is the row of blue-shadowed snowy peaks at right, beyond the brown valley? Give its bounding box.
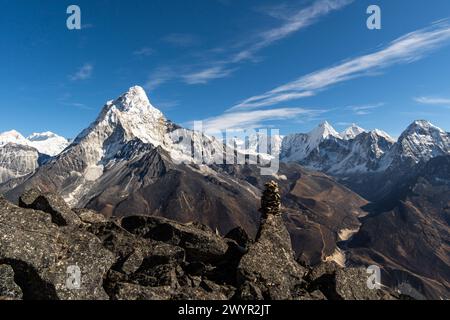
[281,120,450,200]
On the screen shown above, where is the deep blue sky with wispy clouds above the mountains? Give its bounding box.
[0,0,450,137]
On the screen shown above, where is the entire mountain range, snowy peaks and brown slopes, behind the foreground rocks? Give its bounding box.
[0,87,450,298]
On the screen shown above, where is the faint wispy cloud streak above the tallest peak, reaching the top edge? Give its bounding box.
[153,0,354,88]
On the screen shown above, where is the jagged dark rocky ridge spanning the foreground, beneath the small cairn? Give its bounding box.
[0,190,399,300]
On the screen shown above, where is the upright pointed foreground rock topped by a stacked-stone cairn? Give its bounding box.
[238,181,305,300]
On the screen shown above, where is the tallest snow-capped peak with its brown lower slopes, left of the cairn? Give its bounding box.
[0,87,278,233]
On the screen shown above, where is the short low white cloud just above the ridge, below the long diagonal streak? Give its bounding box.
[197,108,324,134]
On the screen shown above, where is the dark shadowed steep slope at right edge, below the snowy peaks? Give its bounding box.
[348,156,450,299]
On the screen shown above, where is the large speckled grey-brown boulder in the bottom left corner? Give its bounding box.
[0,199,114,299]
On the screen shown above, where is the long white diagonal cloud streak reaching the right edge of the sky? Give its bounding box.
[232,20,450,110]
